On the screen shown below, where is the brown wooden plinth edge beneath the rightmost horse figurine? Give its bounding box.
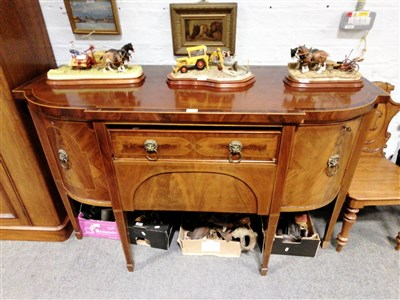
[283,75,364,90]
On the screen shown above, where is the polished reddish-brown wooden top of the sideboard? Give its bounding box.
[14,66,389,124]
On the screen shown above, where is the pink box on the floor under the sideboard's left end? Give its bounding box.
[78,213,120,240]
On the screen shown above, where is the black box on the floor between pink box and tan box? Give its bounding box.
[128,222,174,250]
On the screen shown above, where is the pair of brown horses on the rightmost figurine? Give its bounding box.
[290,45,329,73]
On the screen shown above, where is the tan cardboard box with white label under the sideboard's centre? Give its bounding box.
[178,227,241,257]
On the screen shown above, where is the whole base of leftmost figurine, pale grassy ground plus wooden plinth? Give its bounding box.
[47,66,145,85]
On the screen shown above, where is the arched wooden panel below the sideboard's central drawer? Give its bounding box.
[133,172,257,213]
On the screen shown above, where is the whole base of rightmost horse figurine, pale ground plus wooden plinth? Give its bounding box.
[283,64,364,89]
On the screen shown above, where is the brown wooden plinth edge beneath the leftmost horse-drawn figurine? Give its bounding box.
[46,74,146,86]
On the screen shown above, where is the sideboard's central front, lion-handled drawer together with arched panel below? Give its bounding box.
[109,128,281,215]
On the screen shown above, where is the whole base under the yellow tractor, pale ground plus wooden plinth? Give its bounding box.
[167,66,256,90]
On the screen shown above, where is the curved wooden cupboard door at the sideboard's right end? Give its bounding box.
[282,119,360,211]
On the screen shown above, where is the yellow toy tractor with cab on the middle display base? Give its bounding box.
[173,45,209,73]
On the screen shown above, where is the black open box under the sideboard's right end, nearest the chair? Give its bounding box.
[271,214,321,257]
